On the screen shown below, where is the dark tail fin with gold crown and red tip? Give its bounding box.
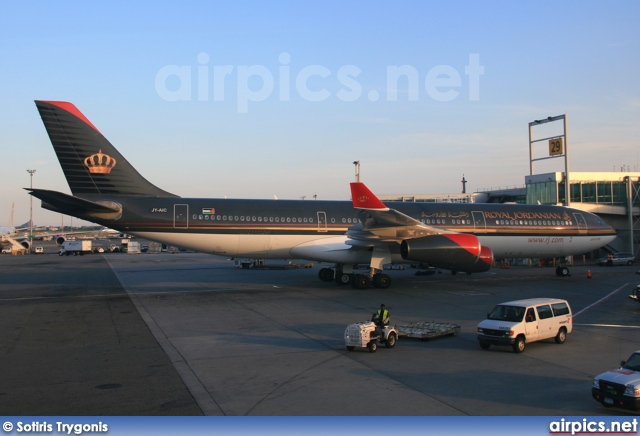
[36,100,177,197]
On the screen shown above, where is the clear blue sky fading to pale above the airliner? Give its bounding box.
[0,0,640,225]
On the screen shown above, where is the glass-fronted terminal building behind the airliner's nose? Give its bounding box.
[379,172,640,257]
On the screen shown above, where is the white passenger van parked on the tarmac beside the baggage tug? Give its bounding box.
[478,298,573,353]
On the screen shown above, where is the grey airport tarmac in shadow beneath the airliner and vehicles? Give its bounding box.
[0,247,640,416]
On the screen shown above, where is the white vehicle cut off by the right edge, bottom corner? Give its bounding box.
[591,350,640,410]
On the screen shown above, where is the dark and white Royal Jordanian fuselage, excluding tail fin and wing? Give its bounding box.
[63,196,615,263]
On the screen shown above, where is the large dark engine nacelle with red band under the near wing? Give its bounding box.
[400,233,493,273]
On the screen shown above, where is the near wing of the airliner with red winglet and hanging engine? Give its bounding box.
[347,182,493,273]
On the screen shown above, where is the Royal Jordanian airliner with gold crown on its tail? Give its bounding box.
[25,100,616,289]
